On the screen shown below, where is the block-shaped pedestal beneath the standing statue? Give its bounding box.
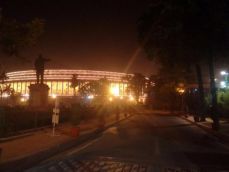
[29,84,49,107]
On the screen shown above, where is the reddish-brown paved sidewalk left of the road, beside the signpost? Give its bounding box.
[0,114,129,165]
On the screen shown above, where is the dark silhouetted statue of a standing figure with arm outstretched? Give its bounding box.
[34,54,50,84]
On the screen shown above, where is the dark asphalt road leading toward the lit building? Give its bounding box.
[28,113,229,171]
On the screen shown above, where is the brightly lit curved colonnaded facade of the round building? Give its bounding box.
[5,69,131,96]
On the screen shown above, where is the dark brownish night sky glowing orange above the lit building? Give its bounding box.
[1,0,156,75]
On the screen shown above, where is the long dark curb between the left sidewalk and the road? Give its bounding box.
[0,115,133,172]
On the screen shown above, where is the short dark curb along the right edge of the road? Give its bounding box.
[179,116,229,145]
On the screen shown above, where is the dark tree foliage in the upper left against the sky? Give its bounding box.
[0,10,45,58]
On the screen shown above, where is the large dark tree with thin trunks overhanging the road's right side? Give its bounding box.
[138,0,229,129]
